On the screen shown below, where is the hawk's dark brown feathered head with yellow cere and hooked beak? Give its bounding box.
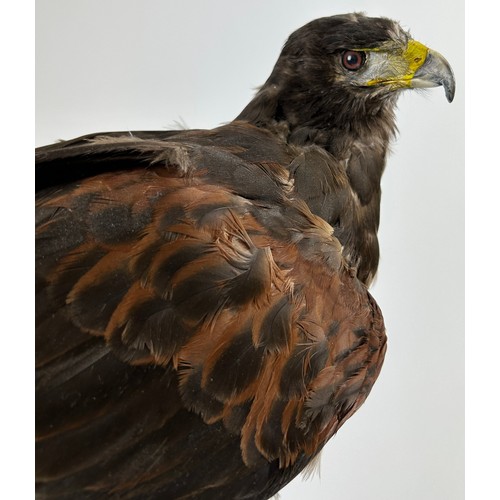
[239,14,455,134]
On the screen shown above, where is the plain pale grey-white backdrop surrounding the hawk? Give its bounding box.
[36,0,464,500]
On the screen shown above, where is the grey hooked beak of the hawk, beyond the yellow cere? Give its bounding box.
[411,45,455,102]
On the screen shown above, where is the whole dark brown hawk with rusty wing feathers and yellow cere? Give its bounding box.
[36,14,455,499]
